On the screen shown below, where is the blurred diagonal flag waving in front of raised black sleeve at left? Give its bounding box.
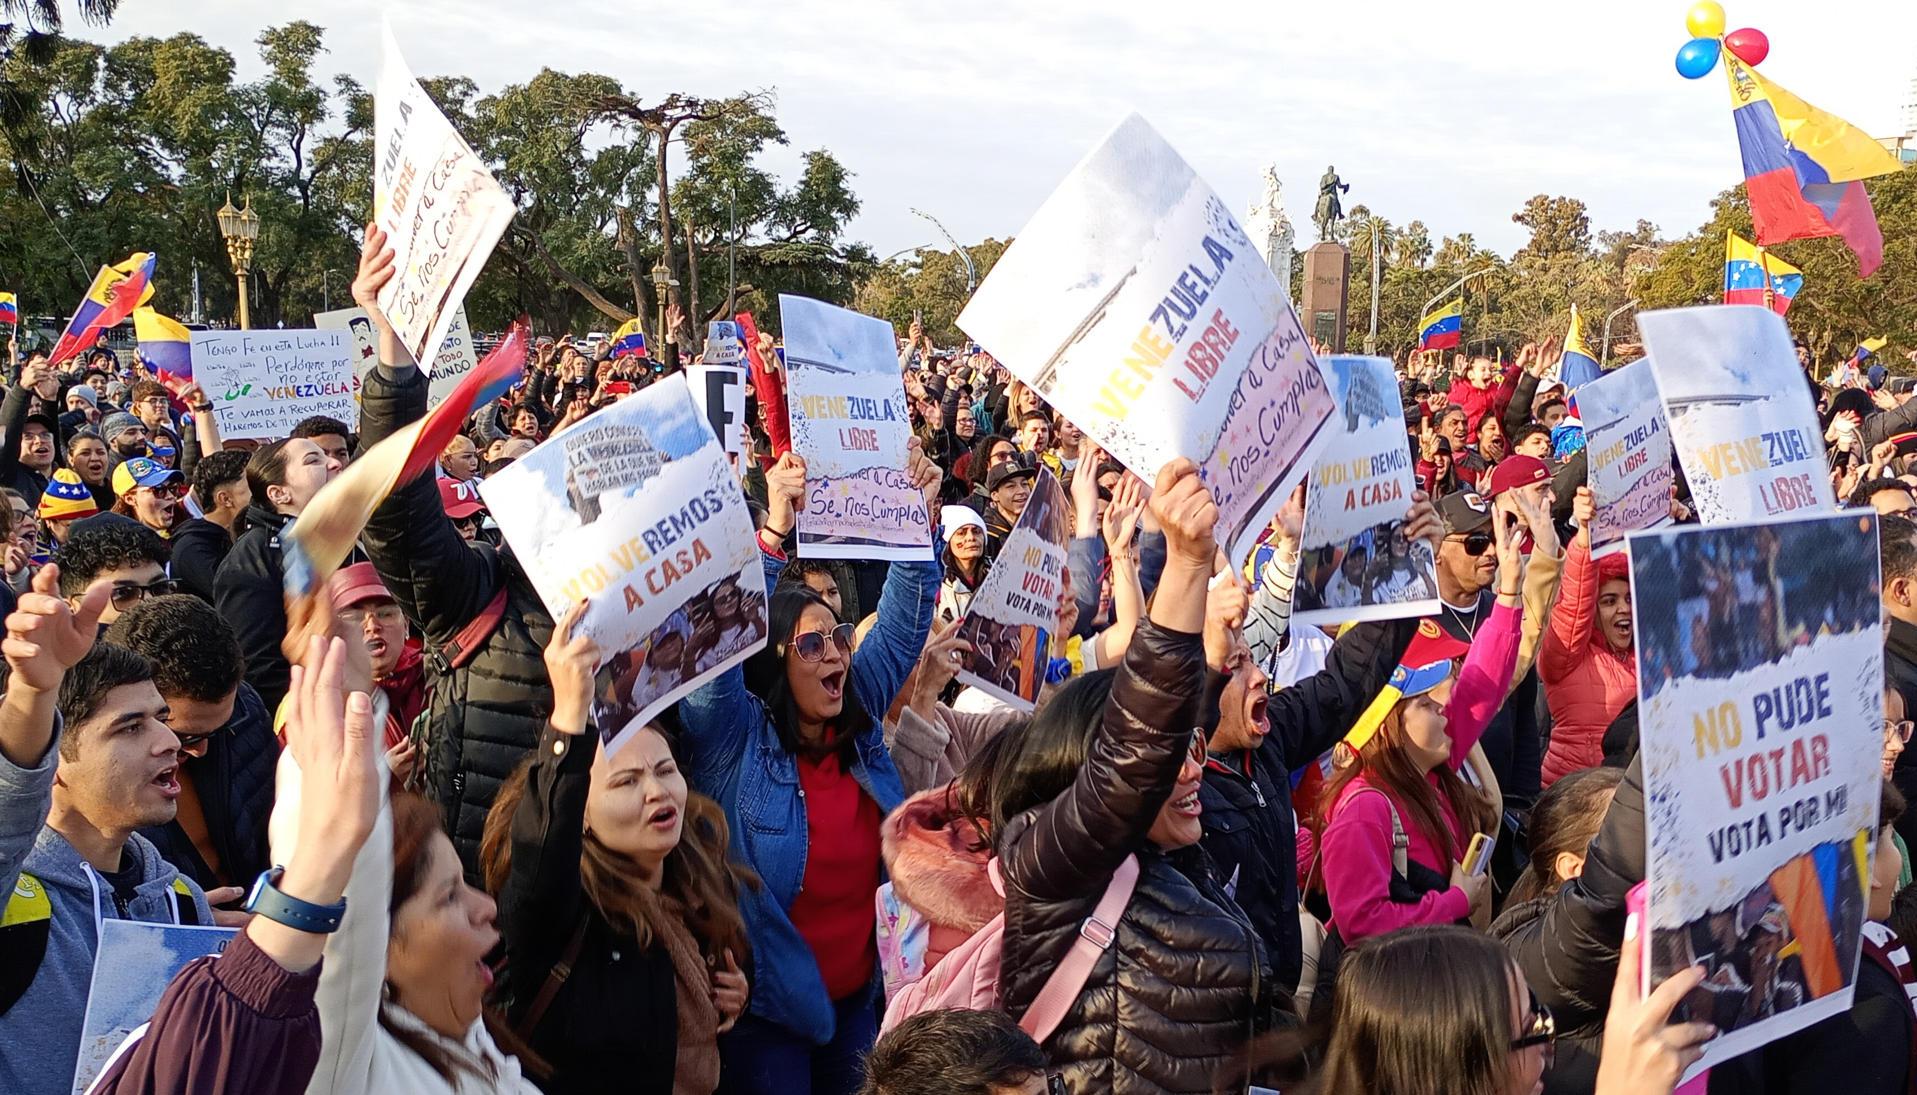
[280,316,531,598]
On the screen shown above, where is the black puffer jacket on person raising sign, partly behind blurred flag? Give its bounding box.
[360,364,552,876]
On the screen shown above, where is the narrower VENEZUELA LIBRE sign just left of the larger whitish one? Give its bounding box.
[1578,359,1672,558]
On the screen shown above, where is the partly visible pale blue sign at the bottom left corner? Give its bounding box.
[73,919,234,1095]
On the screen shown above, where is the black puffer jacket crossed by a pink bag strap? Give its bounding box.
[999,623,1271,1093]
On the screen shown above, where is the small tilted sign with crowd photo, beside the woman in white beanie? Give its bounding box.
[959,468,1095,711]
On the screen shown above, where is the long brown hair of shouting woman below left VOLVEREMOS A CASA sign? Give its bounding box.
[479,711,759,965]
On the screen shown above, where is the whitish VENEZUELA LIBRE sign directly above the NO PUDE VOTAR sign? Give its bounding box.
[1637,305,1836,524]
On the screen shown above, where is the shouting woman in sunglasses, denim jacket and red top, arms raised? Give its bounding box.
[679,437,939,1095]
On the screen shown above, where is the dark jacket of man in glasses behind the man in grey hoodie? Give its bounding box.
[140,681,280,890]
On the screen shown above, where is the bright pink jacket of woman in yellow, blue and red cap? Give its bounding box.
[1321,604,1522,944]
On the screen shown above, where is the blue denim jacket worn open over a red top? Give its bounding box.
[679,556,941,1045]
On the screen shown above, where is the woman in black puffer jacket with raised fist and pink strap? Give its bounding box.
[983,460,1273,1093]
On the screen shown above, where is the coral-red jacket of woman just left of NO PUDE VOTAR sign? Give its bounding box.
[1537,537,1637,786]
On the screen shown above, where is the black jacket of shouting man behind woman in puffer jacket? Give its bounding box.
[1198,619,1419,991]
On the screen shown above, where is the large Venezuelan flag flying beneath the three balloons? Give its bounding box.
[1723,52,1902,278]
